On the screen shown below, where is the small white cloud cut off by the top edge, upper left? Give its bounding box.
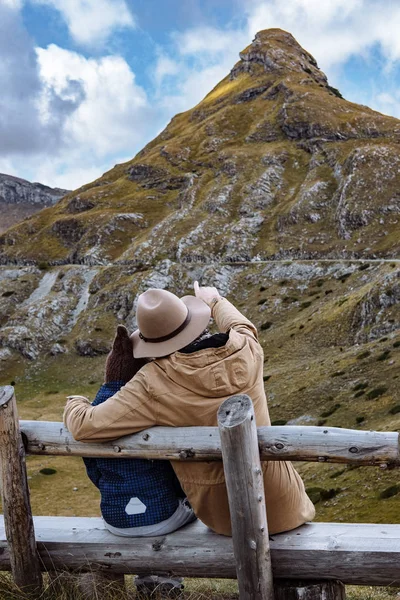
[31,0,135,46]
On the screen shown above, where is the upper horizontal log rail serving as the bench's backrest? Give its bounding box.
[20,421,400,466]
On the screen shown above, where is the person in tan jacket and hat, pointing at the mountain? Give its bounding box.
[64,282,315,535]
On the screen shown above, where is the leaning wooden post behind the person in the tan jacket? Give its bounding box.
[218,395,274,600]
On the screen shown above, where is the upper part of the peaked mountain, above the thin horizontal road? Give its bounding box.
[0,30,400,265]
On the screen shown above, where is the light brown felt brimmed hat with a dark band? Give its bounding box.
[131,288,211,358]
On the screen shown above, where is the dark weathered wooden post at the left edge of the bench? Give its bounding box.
[0,385,42,595]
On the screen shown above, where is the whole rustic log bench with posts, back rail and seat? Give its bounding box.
[0,386,400,600]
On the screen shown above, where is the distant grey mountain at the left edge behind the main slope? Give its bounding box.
[0,173,69,233]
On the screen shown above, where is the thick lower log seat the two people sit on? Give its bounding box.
[0,516,400,586]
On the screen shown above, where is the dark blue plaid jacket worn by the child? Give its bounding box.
[83,381,185,528]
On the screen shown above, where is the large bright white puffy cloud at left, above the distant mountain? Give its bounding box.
[22,44,155,188]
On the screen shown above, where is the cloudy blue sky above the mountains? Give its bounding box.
[0,0,400,189]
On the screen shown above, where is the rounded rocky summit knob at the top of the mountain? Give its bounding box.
[231,29,328,85]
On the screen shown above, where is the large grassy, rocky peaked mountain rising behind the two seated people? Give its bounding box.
[0,29,400,523]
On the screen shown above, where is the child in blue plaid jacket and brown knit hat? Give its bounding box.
[83,325,196,597]
